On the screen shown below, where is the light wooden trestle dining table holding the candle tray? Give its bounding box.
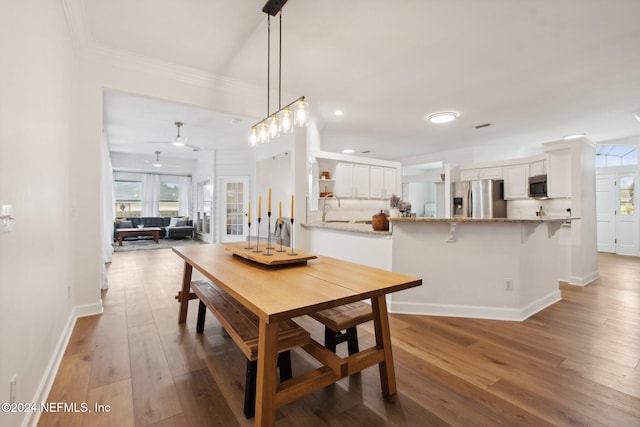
[173,243,422,426]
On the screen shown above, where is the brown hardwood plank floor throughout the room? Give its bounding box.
[39,249,640,427]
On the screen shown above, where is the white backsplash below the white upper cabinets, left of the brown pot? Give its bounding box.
[307,198,389,223]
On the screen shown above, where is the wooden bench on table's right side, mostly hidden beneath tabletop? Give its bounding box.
[310,301,373,355]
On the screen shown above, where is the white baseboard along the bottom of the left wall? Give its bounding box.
[21,300,103,427]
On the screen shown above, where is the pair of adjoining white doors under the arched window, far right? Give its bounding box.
[596,171,638,255]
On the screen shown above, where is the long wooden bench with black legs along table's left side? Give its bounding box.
[191,280,311,418]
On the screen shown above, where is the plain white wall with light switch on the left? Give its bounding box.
[0,0,77,426]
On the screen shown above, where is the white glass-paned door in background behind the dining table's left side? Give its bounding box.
[218,176,249,243]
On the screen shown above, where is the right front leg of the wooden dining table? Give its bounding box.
[371,295,397,396]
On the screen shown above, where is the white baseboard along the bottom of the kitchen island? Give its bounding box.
[389,290,562,322]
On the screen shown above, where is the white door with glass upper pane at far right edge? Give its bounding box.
[616,174,638,255]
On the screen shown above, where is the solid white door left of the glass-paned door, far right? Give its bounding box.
[596,175,616,253]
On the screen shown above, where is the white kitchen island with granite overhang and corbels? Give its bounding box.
[391,217,579,320]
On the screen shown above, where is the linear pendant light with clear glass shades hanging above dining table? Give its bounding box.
[249,0,309,147]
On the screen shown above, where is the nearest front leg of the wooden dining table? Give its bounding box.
[255,319,278,426]
